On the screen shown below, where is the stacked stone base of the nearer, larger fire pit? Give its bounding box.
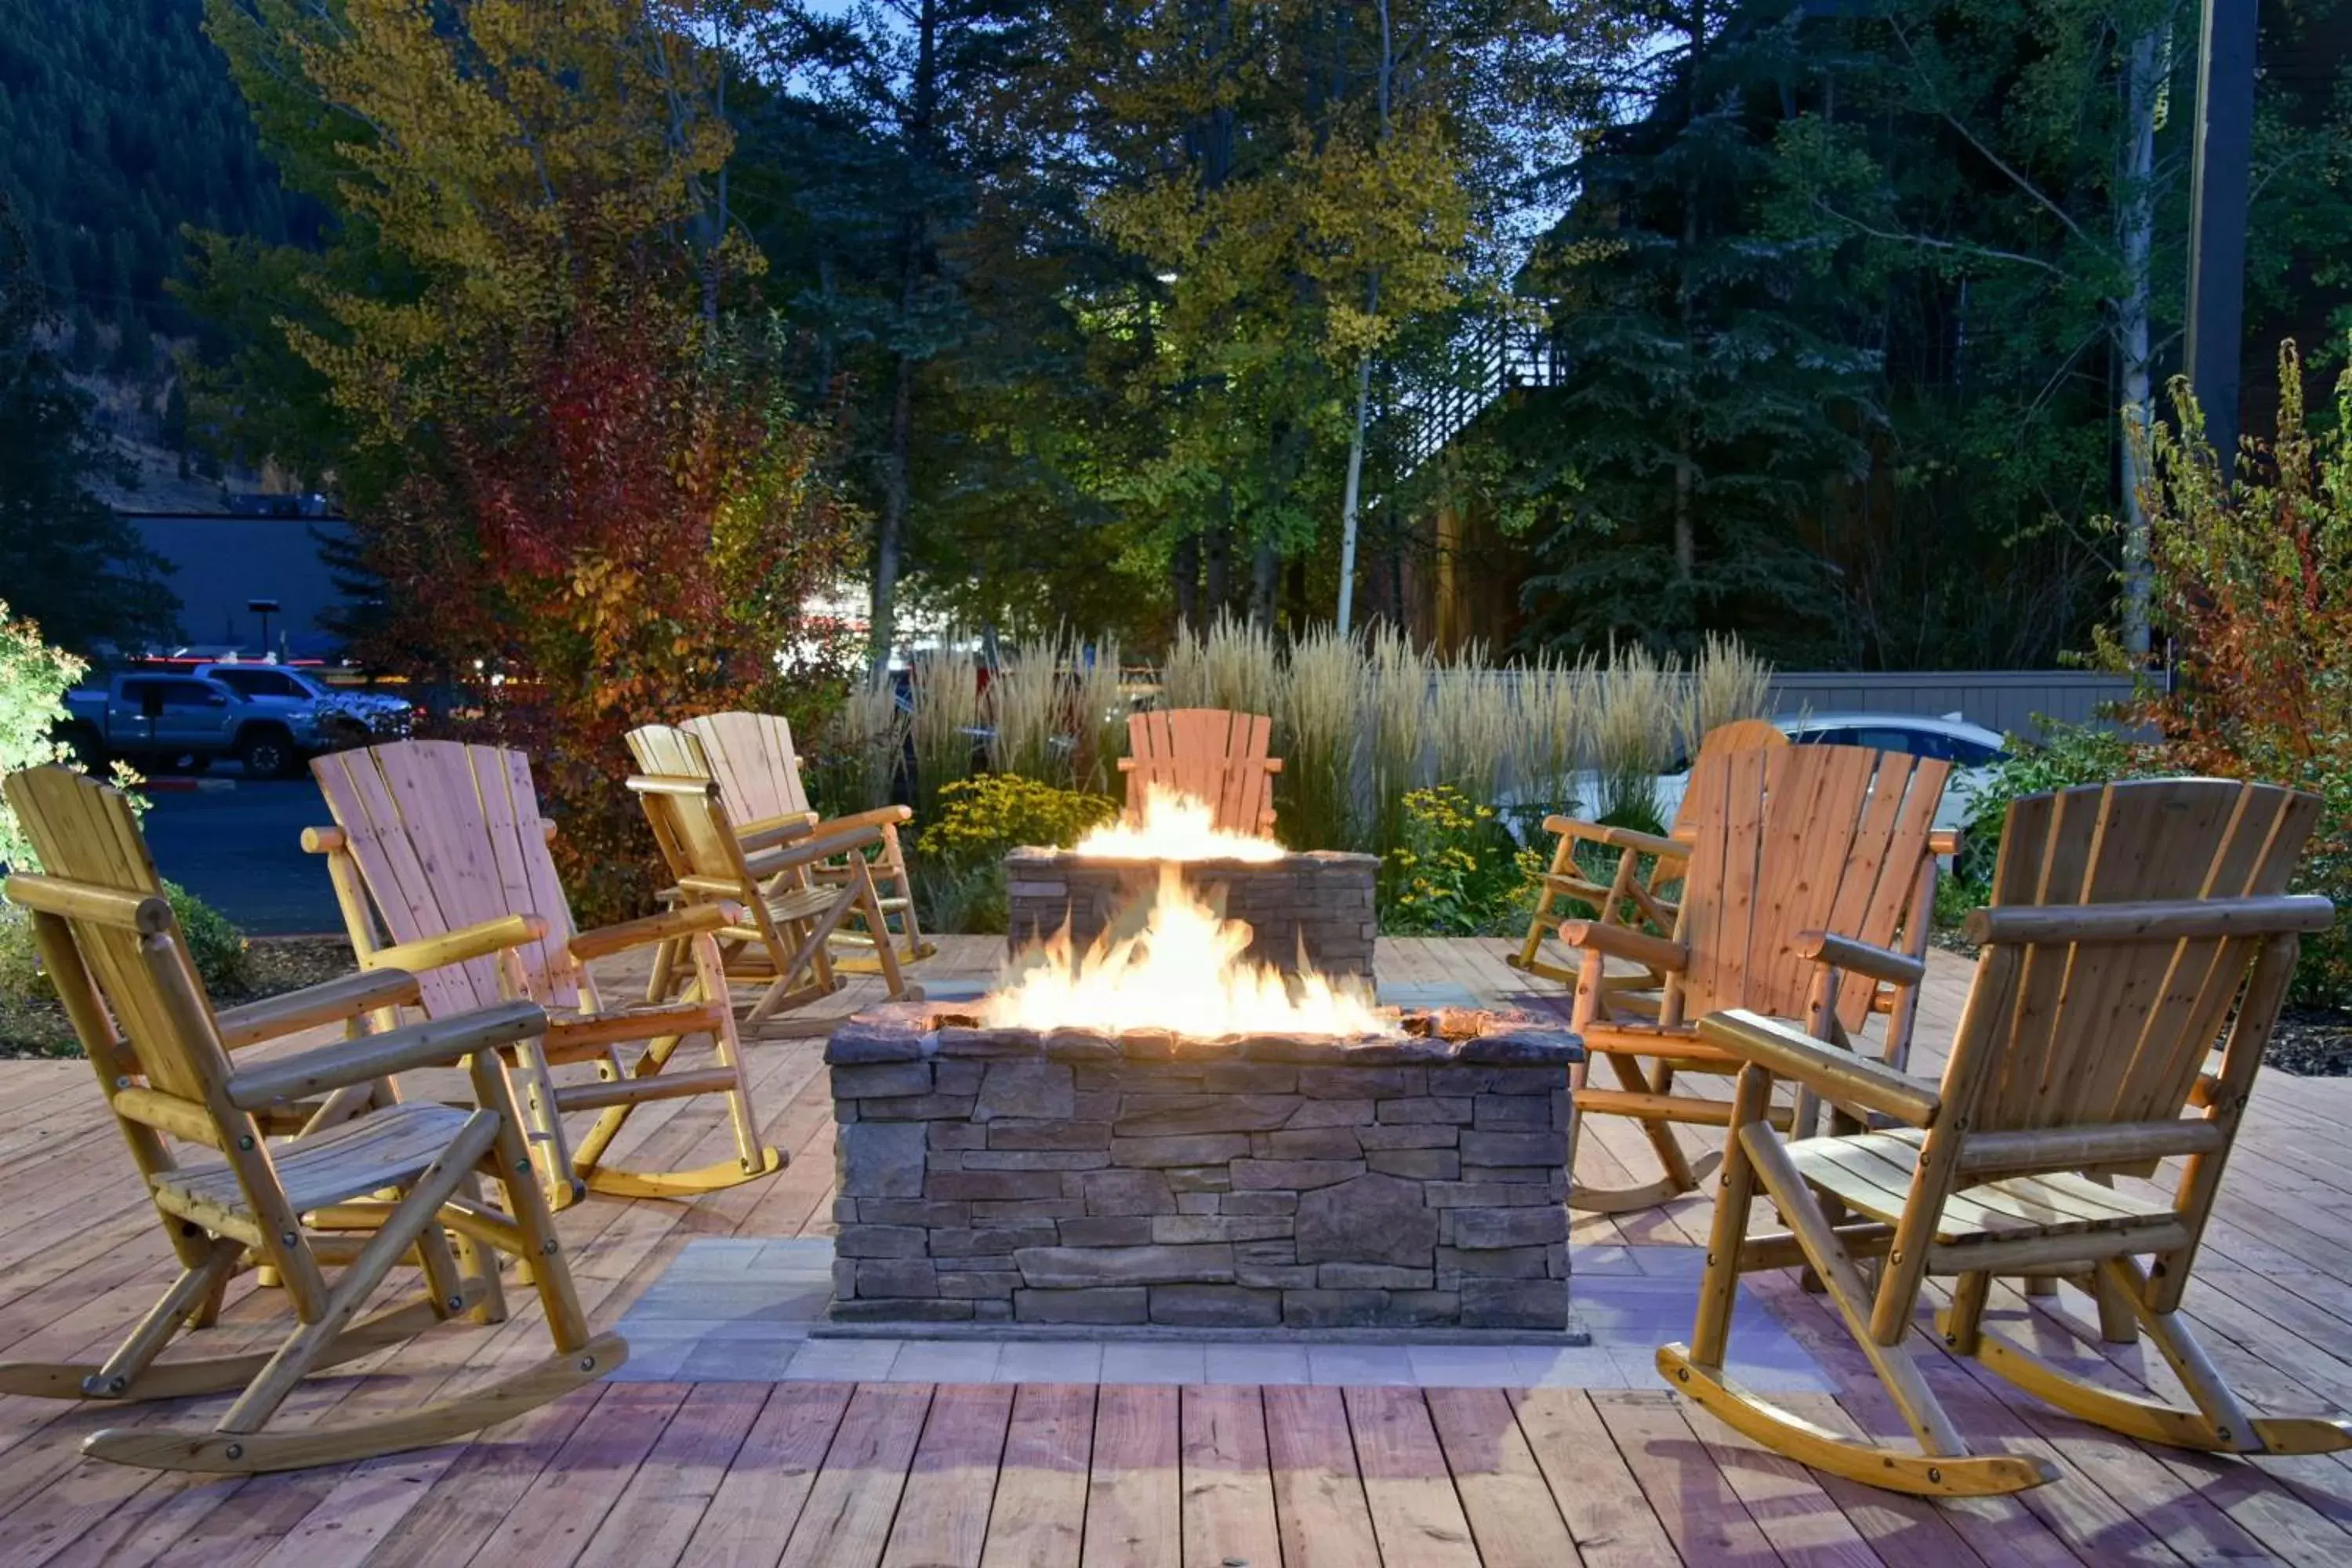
[826,1004,1581,1328]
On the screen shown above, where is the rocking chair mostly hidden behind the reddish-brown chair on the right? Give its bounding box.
[1503,720,1788,992]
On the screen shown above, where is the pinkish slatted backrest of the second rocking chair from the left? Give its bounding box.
[310,741,583,1018]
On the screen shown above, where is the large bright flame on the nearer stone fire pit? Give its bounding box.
[978,860,1399,1036]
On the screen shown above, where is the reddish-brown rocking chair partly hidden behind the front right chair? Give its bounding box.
[1559,746,1952,1213]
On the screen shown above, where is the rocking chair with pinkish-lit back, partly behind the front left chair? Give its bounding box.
[303,741,783,1206]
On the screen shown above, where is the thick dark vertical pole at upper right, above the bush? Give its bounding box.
[2183,0,2258,480]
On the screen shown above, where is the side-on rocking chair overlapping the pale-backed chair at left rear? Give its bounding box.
[628,724,922,1032]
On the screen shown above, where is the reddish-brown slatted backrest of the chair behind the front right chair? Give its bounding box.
[1663,743,1952,1029]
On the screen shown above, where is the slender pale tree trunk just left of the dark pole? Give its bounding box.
[2114,28,2164,661]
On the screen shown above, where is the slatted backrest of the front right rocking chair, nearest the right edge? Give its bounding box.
[1947,779,2319,1133]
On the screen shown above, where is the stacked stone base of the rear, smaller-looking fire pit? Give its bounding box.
[1004,848,1381,980]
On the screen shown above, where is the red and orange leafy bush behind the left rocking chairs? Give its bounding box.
[360,292,851,919]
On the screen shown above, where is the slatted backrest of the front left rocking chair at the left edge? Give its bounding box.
[5,767,228,1105]
